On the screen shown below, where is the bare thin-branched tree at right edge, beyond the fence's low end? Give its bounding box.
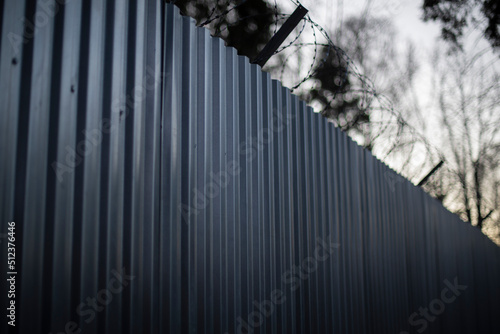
[425,47,500,236]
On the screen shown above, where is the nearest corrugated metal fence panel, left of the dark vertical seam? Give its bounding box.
[0,0,164,333]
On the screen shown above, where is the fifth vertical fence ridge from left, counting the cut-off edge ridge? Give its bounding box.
[103,1,133,332]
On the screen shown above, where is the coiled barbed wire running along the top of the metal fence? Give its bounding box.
[169,0,500,235]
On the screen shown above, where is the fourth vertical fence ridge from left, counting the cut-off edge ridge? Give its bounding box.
[79,3,109,333]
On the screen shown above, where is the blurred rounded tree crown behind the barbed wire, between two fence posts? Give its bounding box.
[305,12,415,150]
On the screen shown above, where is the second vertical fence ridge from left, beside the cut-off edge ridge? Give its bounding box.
[19,3,54,332]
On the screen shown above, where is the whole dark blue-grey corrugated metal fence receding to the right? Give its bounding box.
[0,0,500,333]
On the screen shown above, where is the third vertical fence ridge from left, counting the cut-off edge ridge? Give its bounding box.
[49,3,82,330]
